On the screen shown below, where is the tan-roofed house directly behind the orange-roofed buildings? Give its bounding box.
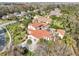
[32,16,52,24]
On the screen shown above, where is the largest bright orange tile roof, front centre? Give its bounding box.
[31,30,52,38]
